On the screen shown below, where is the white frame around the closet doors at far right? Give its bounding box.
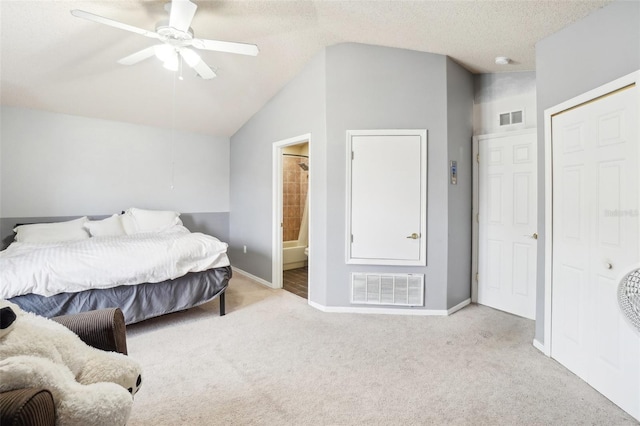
[536,71,640,357]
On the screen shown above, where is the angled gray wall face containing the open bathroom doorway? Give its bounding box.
[229,51,327,304]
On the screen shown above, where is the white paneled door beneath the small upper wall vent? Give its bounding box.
[477,130,537,319]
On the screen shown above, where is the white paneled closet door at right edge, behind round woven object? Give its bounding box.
[551,83,640,419]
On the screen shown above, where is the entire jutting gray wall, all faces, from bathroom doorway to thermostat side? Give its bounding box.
[230,43,473,309]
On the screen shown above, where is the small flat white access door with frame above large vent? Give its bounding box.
[347,130,427,265]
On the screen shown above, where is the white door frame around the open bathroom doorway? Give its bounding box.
[271,133,313,288]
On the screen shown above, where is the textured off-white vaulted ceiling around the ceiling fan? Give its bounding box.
[0,0,611,136]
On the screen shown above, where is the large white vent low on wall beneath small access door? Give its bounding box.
[351,272,424,306]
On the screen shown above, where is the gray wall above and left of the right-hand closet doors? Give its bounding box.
[535,1,640,344]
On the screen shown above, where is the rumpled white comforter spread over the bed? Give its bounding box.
[0,226,229,299]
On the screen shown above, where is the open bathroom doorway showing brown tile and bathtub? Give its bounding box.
[272,135,310,299]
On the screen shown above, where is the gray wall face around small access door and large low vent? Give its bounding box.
[327,43,450,309]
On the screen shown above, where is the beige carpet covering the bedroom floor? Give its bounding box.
[128,274,637,426]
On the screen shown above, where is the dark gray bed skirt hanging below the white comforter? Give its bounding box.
[9,266,231,324]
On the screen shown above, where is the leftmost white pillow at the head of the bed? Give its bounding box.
[13,216,89,243]
